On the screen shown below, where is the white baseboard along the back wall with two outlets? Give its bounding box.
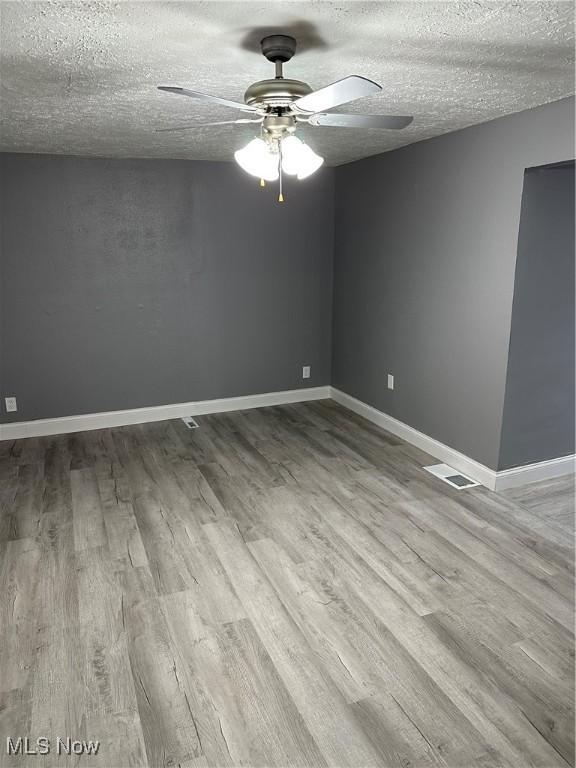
[0,386,330,440]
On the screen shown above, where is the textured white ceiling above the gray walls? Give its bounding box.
[0,0,574,165]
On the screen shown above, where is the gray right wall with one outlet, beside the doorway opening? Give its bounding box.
[332,99,574,469]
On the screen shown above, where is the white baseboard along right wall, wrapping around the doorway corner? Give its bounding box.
[331,387,576,491]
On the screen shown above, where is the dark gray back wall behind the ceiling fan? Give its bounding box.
[0,154,334,422]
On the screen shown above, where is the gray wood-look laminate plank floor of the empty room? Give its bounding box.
[0,401,574,768]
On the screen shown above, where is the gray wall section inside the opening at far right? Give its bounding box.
[499,164,576,469]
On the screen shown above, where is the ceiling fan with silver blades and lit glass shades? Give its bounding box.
[158,35,413,202]
